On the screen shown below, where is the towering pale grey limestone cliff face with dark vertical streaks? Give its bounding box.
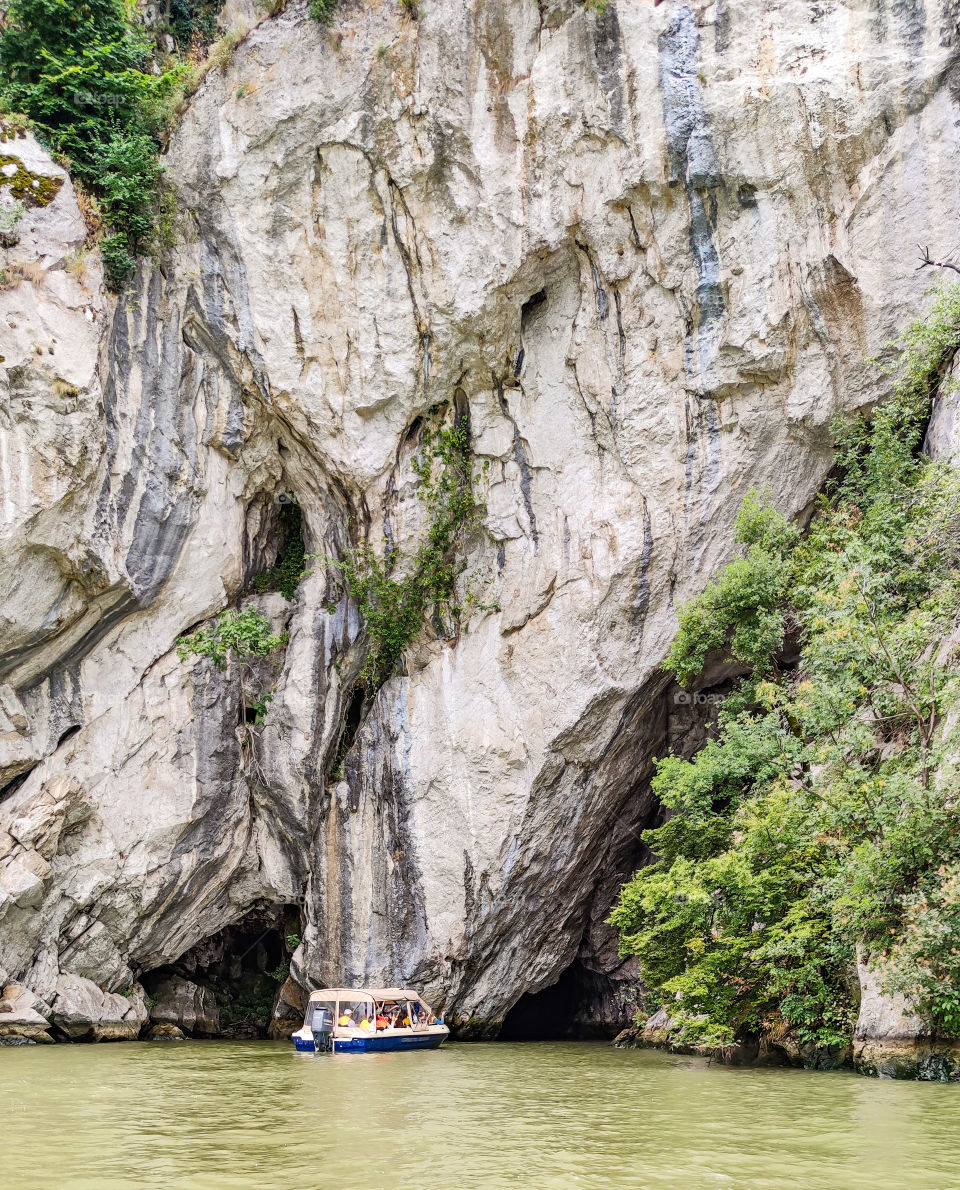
[0,0,960,1033]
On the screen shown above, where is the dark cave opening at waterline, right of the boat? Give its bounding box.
[500,958,635,1041]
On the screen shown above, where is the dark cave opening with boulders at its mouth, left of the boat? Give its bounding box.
[143,904,301,1039]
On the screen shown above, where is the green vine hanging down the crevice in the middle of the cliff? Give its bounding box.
[327,417,483,691]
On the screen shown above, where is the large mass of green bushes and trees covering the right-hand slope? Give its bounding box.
[610,286,960,1046]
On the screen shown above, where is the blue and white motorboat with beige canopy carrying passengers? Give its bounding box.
[293,988,450,1053]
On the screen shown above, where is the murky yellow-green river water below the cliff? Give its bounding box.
[0,1042,960,1190]
